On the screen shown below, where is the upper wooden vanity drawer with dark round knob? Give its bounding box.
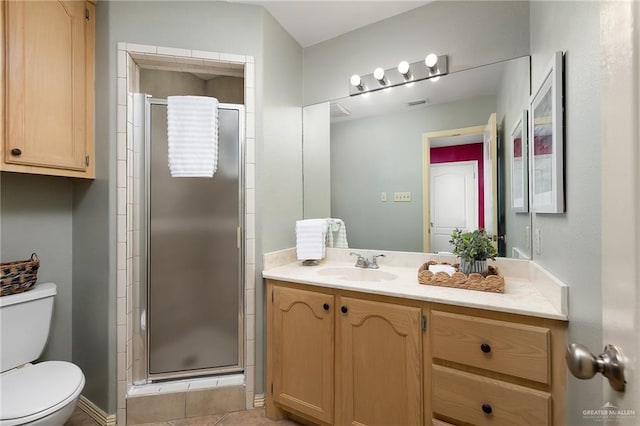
[431,311,550,383]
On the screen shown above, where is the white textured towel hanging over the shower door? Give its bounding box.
[167,96,218,177]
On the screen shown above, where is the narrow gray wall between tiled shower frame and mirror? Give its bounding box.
[255,11,302,394]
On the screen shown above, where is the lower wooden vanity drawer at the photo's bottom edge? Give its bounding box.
[432,365,551,426]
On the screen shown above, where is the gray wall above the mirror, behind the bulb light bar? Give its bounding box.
[304,1,529,105]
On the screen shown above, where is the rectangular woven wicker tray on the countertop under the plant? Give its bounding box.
[418,260,504,293]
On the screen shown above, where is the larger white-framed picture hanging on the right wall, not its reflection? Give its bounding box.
[529,52,564,213]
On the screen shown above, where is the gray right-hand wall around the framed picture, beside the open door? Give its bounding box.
[531,1,606,425]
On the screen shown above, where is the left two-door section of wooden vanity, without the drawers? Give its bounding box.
[267,280,423,425]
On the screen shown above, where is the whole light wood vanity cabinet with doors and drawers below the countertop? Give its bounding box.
[266,279,566,426]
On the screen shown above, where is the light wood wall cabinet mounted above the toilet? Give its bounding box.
[0,0,95,178]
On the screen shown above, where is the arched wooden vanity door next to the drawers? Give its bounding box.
[336,297,422,425]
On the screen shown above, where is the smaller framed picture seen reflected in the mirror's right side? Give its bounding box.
[510,110,529,213]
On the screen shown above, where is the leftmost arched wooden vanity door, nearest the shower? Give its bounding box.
[270,286,335,423]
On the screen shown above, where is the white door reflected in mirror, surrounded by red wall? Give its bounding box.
[430,161,478,253]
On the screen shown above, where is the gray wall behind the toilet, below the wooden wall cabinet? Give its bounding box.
[0,172,73,361]
